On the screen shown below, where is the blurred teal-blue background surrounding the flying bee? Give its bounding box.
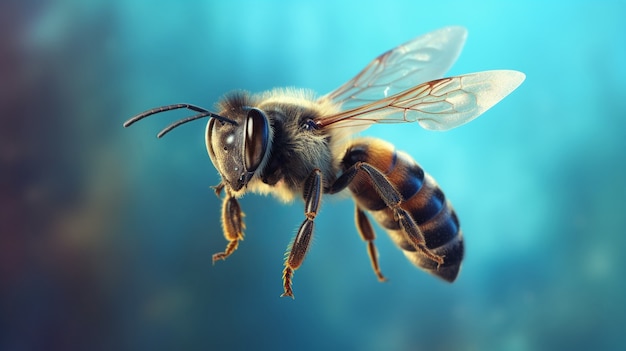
[0,0,626,351]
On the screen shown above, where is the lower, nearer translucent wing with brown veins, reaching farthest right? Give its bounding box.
[317,70,525,132]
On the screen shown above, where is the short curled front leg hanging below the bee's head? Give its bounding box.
[213,191,246,263]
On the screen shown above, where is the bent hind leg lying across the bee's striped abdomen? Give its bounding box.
[328,162,443,265]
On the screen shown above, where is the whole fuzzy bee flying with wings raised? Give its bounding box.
[124,27,525,298]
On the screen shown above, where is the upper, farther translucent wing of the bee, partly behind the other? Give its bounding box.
[320,27,467,110]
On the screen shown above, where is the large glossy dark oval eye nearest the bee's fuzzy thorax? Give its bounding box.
[243,108,270,172]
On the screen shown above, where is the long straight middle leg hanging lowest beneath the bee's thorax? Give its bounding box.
[281,169,322,298]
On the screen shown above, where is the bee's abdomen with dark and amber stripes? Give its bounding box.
[342,138,463,282]
